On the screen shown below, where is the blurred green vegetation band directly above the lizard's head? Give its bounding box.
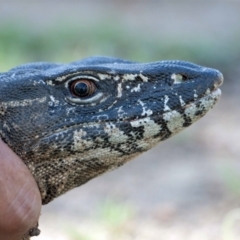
[0,23,240,75]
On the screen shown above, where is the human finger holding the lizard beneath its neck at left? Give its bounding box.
[0,139,42,240]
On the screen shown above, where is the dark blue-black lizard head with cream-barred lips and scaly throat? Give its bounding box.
[0,57,223,239]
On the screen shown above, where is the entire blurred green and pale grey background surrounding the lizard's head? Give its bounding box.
[0,0,240,240]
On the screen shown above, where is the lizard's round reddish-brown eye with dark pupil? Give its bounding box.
[70,79,96,98]
